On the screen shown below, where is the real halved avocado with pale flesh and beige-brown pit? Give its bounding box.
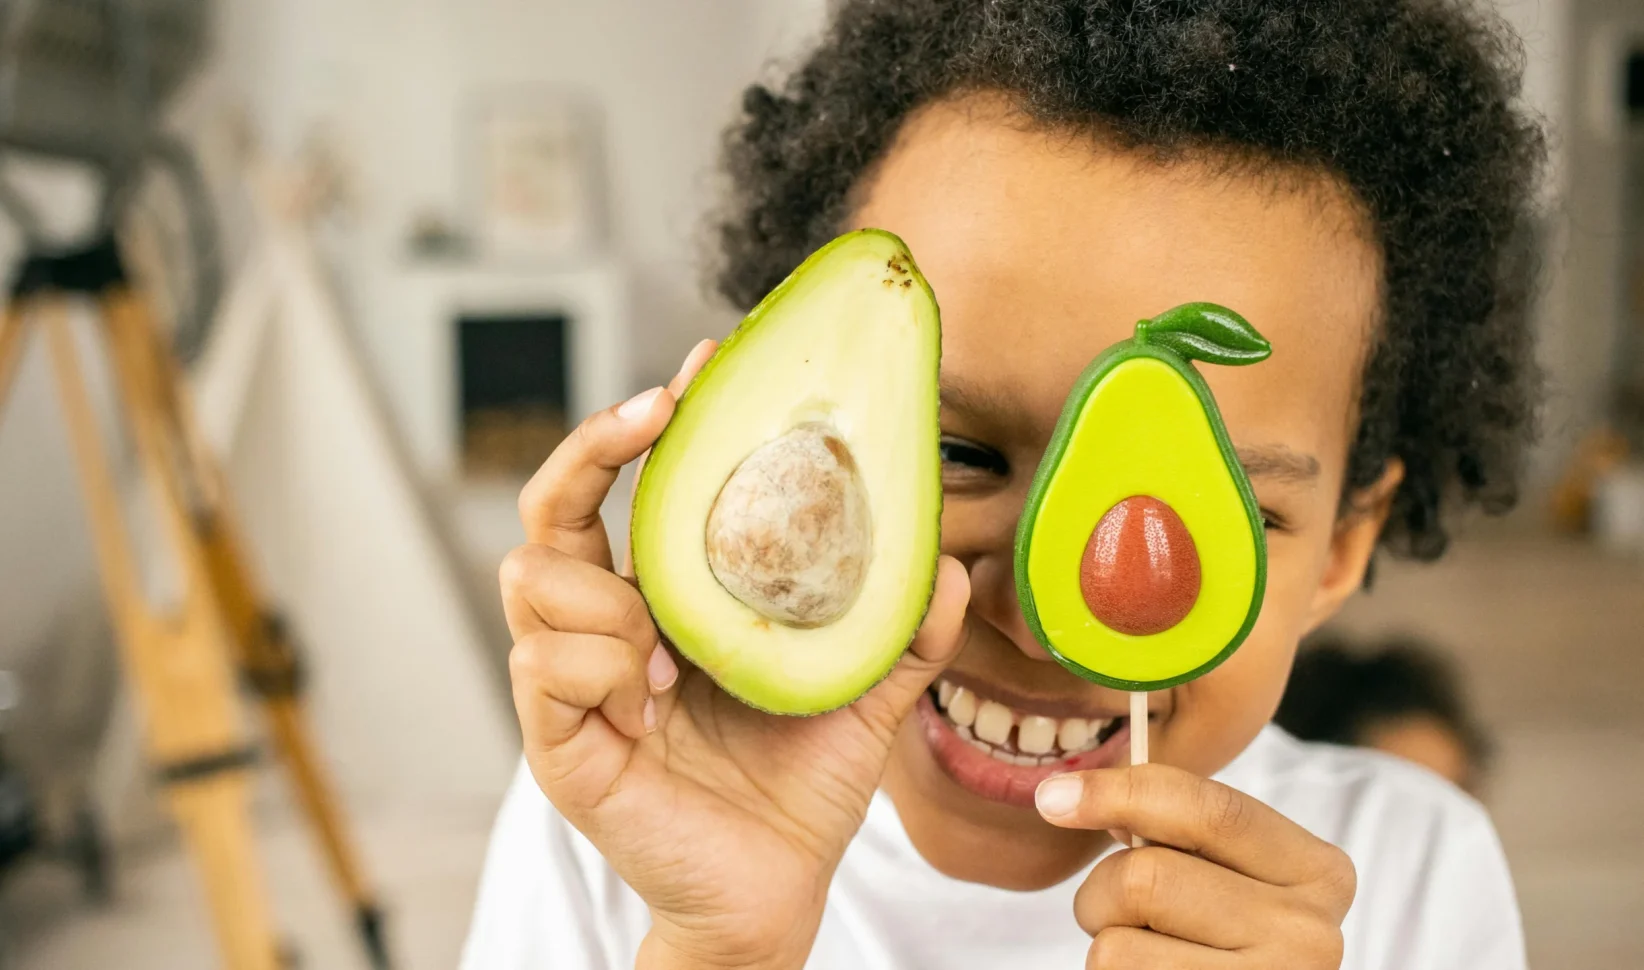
[631,229,942,715]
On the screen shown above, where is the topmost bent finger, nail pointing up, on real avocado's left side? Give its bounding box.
[520,388,674,569]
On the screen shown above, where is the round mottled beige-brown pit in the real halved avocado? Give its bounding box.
[707,421,873,628]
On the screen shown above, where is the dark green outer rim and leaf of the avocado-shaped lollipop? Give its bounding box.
[1014,304,1269,691]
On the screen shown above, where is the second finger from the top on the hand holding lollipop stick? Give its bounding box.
[1074,847,1300,950]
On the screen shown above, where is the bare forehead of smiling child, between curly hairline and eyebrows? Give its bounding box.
[853,99,1379,480]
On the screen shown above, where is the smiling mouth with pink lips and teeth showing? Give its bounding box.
[919,677,1129,807]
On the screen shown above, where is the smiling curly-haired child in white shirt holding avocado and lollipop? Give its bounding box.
[464,0,1540,970]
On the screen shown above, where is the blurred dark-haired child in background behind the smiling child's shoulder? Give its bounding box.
[1272,636,1489,794]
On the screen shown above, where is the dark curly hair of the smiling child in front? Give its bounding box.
[717,0,1544,559]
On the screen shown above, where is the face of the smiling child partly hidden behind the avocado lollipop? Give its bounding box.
[852,97,1397,888]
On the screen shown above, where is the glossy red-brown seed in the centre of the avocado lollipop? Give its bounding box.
[1078,495,1198,636]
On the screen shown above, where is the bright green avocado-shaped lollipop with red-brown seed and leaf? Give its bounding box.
[1016,303,1271,691]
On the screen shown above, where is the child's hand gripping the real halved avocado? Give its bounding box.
[501,340,970,967]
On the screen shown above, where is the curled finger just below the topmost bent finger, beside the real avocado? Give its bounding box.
[498,546,659,658]
